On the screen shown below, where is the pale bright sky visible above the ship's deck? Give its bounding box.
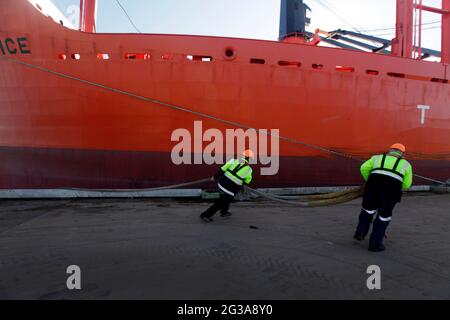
[53,0,441,50]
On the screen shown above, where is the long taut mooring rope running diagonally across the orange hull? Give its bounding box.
[0,56,447,185]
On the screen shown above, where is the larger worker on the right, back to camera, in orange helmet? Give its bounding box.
[354,143,413,252]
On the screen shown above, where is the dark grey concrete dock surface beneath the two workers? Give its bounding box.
[0,193,450,300]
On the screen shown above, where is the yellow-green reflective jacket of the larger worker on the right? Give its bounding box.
[360,153,413,189]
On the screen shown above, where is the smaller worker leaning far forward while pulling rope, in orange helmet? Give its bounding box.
[200,150,255,222]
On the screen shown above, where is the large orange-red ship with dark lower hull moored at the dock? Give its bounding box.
[0,0,450,190]
